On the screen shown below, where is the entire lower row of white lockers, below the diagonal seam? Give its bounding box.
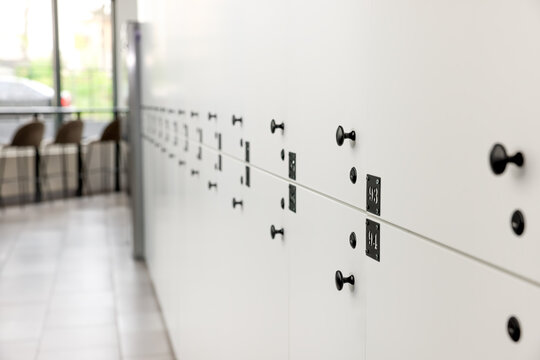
[143,133,540,360]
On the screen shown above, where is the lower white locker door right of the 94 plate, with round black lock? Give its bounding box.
[366,219,540,360]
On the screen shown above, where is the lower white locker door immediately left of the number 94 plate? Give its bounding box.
[283,188,366,360]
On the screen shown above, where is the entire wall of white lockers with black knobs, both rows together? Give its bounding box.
[139,0,540,360]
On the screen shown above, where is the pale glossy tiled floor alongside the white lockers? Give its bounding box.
[0,194,174,360]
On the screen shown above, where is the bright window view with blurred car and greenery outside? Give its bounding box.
[0,0,114,143]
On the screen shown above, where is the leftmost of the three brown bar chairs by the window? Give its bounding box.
[0,121,45,206]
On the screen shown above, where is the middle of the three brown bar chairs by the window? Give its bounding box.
[41,120,84,197]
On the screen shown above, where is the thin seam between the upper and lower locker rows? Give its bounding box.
[161,137,540,287]
